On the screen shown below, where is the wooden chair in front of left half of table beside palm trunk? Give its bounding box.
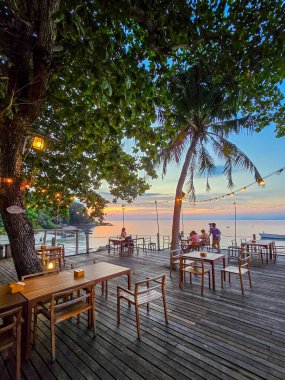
[179,256,211,296]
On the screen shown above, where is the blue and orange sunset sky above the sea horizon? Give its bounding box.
[106,121,285,220]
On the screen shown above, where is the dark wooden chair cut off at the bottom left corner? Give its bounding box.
[0,307,22,380]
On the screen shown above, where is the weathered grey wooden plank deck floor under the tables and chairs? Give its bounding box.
[0,251,285,380]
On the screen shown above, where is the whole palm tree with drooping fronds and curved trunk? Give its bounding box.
[160,63,262,249]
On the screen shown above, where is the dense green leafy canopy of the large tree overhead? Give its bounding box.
[0,0,285,223]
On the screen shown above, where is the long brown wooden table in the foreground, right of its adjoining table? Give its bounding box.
[18,262,132,359]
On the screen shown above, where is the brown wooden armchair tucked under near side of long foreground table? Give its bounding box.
[34,285,96,362]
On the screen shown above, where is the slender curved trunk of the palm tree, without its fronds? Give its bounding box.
[171,139,198,250]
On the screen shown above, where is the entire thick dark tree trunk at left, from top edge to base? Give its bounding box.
[0,0,60,277]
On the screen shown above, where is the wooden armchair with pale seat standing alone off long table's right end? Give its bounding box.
[117,275,168,339]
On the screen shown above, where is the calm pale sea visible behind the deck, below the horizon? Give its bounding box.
[0,220,285,255]
